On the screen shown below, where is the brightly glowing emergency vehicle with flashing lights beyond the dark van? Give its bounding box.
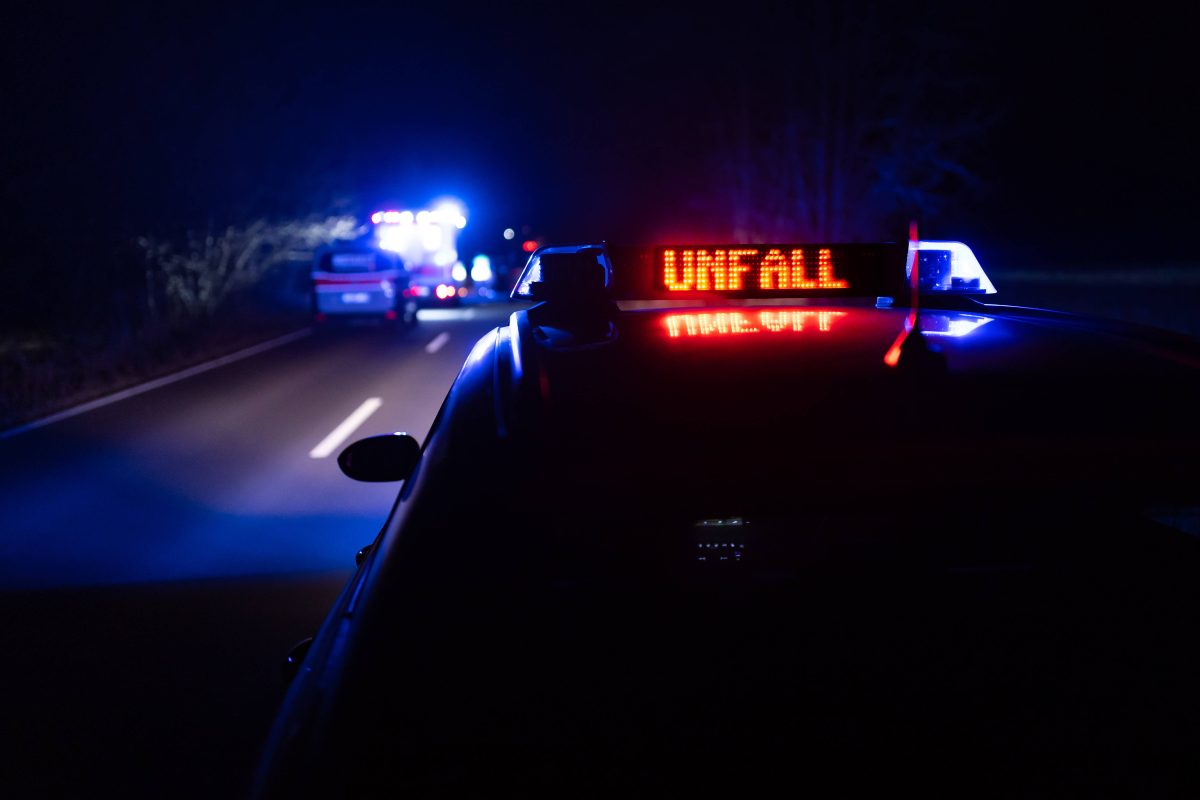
[371,200,493,306]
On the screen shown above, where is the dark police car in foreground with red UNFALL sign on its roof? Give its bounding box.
[256,240,1200,798]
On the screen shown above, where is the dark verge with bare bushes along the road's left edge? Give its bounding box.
[0,216,361,432]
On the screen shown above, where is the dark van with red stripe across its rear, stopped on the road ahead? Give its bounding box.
[312,243,416,326]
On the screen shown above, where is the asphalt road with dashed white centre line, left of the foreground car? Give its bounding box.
[0,305,512,798]
